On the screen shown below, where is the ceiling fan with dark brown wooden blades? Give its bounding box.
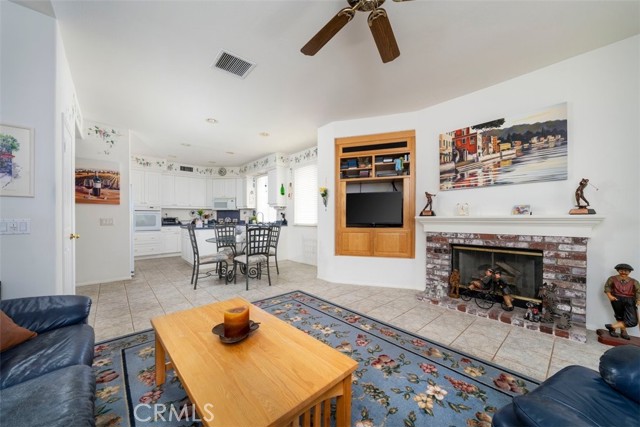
[300,0,410,63]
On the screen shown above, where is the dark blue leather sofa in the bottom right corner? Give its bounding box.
[492,345,640,427]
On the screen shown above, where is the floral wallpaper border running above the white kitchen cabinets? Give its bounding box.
[131,147,318,177]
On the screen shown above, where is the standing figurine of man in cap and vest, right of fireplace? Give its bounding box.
[604,264,640,340]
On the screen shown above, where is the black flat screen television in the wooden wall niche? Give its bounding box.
[347,191,402,227]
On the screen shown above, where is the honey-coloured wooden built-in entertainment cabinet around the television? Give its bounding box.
[335,130,415,258]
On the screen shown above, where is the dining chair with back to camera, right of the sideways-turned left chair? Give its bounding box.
[232,225,271,290]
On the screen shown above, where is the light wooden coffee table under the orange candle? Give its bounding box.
[151,298,358,427]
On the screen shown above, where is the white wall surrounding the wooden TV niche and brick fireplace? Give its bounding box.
[318,36,640,335]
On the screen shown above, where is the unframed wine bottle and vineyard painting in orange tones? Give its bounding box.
[75,158,120,205]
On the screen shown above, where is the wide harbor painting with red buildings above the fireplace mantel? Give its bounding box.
[439,103,568,191]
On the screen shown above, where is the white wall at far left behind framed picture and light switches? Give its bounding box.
[0,1,62,298]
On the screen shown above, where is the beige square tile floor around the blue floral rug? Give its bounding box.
[77,257,609,380]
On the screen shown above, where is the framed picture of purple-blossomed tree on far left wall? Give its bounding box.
[0,125,35,197]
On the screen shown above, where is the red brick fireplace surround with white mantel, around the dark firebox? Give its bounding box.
[416,215,603,342]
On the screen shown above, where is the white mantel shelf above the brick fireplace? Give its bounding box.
[416,215,605,237]
